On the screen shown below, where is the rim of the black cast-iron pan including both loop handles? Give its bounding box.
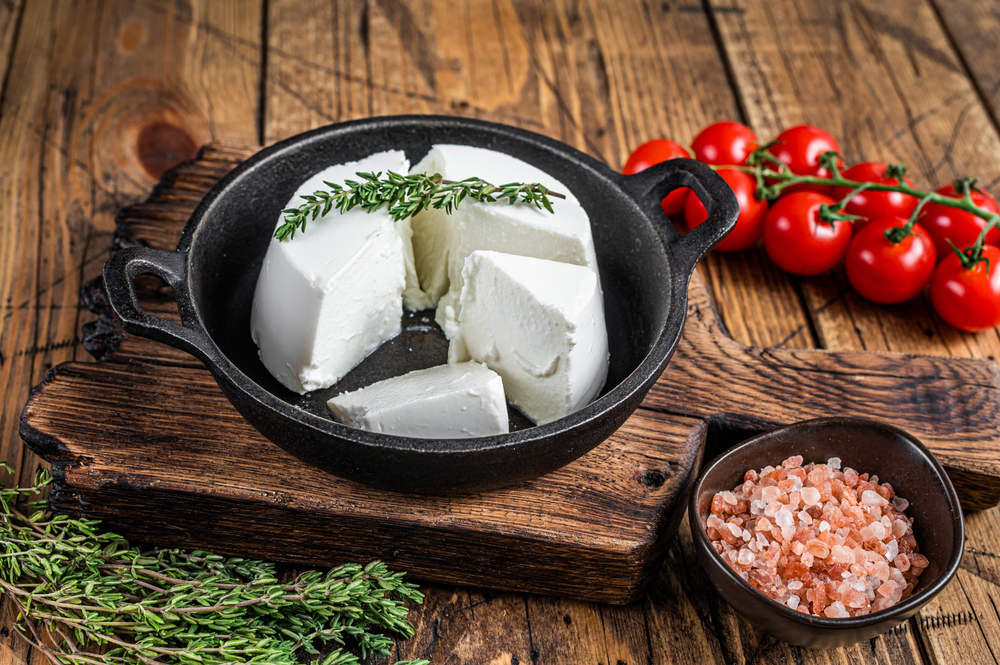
[104,115,738,455]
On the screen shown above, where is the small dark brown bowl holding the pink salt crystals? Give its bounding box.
[688,418,965,648]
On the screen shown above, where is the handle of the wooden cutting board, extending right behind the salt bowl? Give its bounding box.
[645,282,1000,509]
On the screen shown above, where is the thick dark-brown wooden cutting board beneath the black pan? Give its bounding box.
[21,145,1000,603]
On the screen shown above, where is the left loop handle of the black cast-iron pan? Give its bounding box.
[104,247,216,366]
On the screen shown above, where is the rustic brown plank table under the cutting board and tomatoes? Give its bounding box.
[0,0,1000,665]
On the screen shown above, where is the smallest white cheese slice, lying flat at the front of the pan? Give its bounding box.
[327,362,509,439]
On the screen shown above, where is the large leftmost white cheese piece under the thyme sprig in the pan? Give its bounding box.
[250,150,415,394]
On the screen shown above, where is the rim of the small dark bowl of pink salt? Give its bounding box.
[688,417,965,629]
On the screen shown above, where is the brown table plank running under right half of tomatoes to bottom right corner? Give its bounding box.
[713,0,1000,663]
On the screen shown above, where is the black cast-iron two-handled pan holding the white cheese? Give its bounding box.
[104,116,739,494]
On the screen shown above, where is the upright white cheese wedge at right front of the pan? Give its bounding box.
[448,251,608,425]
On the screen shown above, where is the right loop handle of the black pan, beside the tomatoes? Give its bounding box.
[625,159,740,273]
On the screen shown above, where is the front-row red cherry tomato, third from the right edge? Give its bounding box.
[764,192,851,275]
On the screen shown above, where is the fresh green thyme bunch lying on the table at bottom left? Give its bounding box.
[0,463,427,665]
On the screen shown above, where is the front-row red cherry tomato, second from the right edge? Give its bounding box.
[845,216,937,305]
